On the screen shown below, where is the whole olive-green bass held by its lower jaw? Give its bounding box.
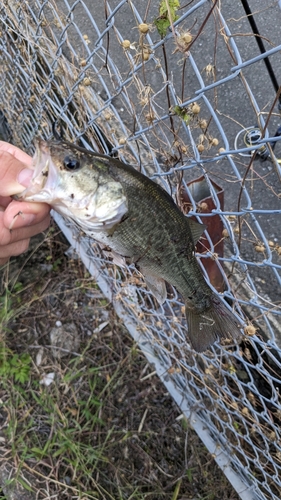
[15,139,241,352]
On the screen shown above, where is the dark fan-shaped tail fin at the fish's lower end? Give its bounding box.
[185,294,241,352]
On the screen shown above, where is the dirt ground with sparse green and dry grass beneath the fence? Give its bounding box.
[0,225,239,500]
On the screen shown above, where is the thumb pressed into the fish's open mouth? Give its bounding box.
[0,150,33,196]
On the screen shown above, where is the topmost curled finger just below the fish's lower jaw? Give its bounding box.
[3,201,50,231]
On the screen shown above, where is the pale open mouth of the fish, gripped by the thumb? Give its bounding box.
[13,139,58,203]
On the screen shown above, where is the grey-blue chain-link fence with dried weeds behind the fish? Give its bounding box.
[0,0,281,500]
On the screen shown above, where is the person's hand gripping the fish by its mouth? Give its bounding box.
[0,141,50,266]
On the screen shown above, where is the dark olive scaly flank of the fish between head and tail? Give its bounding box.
[100,159,209,310]
